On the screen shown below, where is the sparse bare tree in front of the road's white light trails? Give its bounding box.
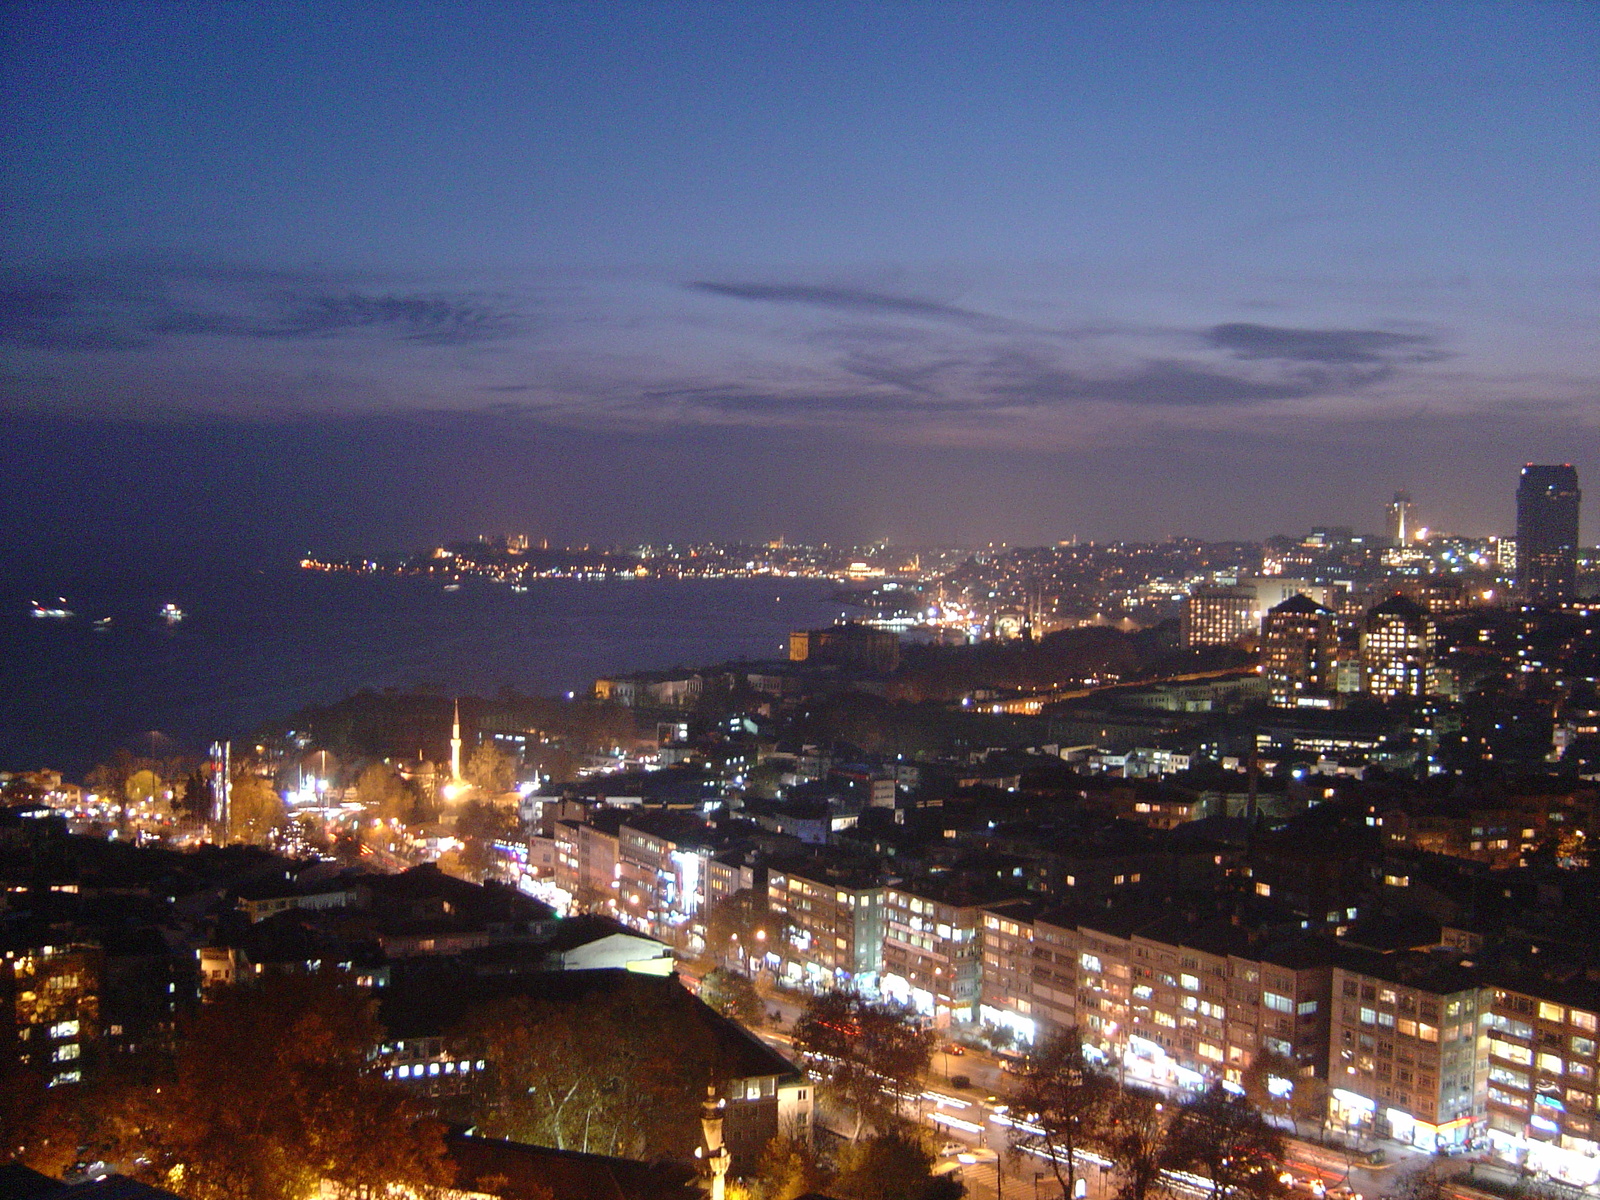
[1011,1026,1117,1195]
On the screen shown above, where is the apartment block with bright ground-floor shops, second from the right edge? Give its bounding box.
[1328,950,1484,1150]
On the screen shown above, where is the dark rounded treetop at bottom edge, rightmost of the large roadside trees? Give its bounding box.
[1163,1083,1283,1200]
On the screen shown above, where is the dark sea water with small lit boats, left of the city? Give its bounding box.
[0,568,843,778]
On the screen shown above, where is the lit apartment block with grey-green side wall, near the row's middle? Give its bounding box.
[766,859,886,992]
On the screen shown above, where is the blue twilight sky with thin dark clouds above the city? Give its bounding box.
[0,2,1600,563]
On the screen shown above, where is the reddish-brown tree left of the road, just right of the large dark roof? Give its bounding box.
[794,992,933,1142]
